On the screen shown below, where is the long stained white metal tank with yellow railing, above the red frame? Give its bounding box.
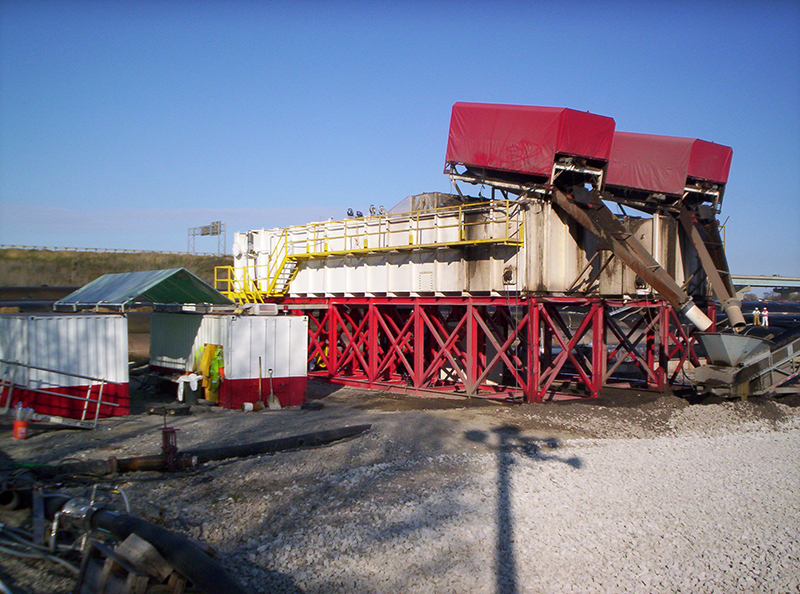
[234,196,700,297]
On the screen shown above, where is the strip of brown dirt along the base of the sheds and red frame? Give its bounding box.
[0,380,800,463]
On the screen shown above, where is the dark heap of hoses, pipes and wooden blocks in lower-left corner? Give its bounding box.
[0,480,246,594]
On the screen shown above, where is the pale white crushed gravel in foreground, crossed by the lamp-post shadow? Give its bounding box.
[223,429,800,593]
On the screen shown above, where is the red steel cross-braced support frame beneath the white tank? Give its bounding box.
[288,297,697,402]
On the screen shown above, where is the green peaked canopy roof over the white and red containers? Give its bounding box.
[55,268,233,309]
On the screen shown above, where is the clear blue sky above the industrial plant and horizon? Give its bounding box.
[0,0,800,276]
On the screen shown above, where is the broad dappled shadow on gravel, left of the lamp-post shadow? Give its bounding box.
[129,415,463,594]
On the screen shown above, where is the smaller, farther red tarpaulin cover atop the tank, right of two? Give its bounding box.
[606,132,733,194]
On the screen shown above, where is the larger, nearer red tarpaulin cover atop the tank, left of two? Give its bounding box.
[446,102,615,177]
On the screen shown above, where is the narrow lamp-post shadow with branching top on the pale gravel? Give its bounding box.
[465,425,582,594]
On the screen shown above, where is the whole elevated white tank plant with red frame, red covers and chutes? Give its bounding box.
[211,103,768,402]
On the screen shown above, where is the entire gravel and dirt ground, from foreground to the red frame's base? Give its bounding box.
[0,387,800,594]
